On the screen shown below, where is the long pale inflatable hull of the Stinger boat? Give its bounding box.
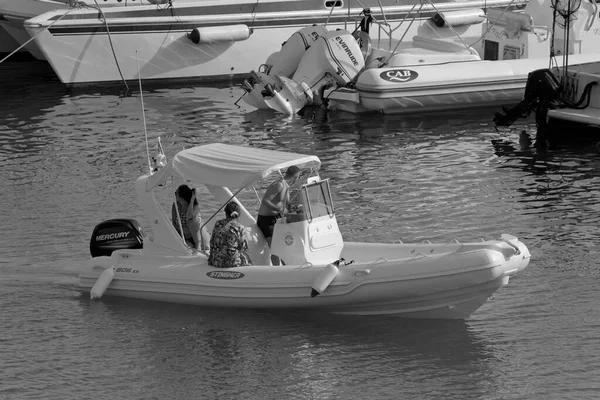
[80,241,530,319]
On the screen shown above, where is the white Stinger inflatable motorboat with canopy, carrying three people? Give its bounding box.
[79,144,530,319]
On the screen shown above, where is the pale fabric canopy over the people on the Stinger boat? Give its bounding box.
[146,143,321,190]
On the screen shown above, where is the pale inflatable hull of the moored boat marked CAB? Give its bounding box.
[327,54,600,114]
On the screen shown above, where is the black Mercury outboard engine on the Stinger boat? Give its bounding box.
[90,218,144,257]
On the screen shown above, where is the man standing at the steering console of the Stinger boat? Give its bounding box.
[256,165,300,265]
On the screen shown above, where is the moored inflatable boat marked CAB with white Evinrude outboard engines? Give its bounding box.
[242,0,600,114]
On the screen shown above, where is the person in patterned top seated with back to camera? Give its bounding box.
[208,201,252,268]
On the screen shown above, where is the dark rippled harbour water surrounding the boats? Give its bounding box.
[0,62,600,399]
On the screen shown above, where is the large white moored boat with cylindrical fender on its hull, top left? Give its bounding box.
[25,0,526,86]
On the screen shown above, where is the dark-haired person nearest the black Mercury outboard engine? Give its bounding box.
[171,185,210,251]
